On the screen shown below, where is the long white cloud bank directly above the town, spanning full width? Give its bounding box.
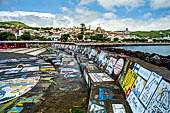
[0,10,170,31]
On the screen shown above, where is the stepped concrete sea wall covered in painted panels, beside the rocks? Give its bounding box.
[59,45,170,113]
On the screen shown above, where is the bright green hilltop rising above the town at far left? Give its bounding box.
[0,21,29,28]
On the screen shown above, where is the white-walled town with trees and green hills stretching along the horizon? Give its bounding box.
[0,21,170,43]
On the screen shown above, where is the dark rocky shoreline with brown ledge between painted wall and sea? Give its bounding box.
[100,48,170,80]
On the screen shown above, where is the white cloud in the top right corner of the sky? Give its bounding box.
[150,0,170,10]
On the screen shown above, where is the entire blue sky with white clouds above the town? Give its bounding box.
[0,0,170,31]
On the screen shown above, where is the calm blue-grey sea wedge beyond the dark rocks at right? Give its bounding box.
[113,45,170,56]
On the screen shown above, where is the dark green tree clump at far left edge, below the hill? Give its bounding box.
[0,32,16,41]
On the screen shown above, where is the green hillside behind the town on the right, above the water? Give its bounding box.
[130,29,170,38]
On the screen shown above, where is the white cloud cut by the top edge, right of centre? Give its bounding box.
[97,0,145,10]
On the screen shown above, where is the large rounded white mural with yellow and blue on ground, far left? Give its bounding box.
[0,76,40,103]
